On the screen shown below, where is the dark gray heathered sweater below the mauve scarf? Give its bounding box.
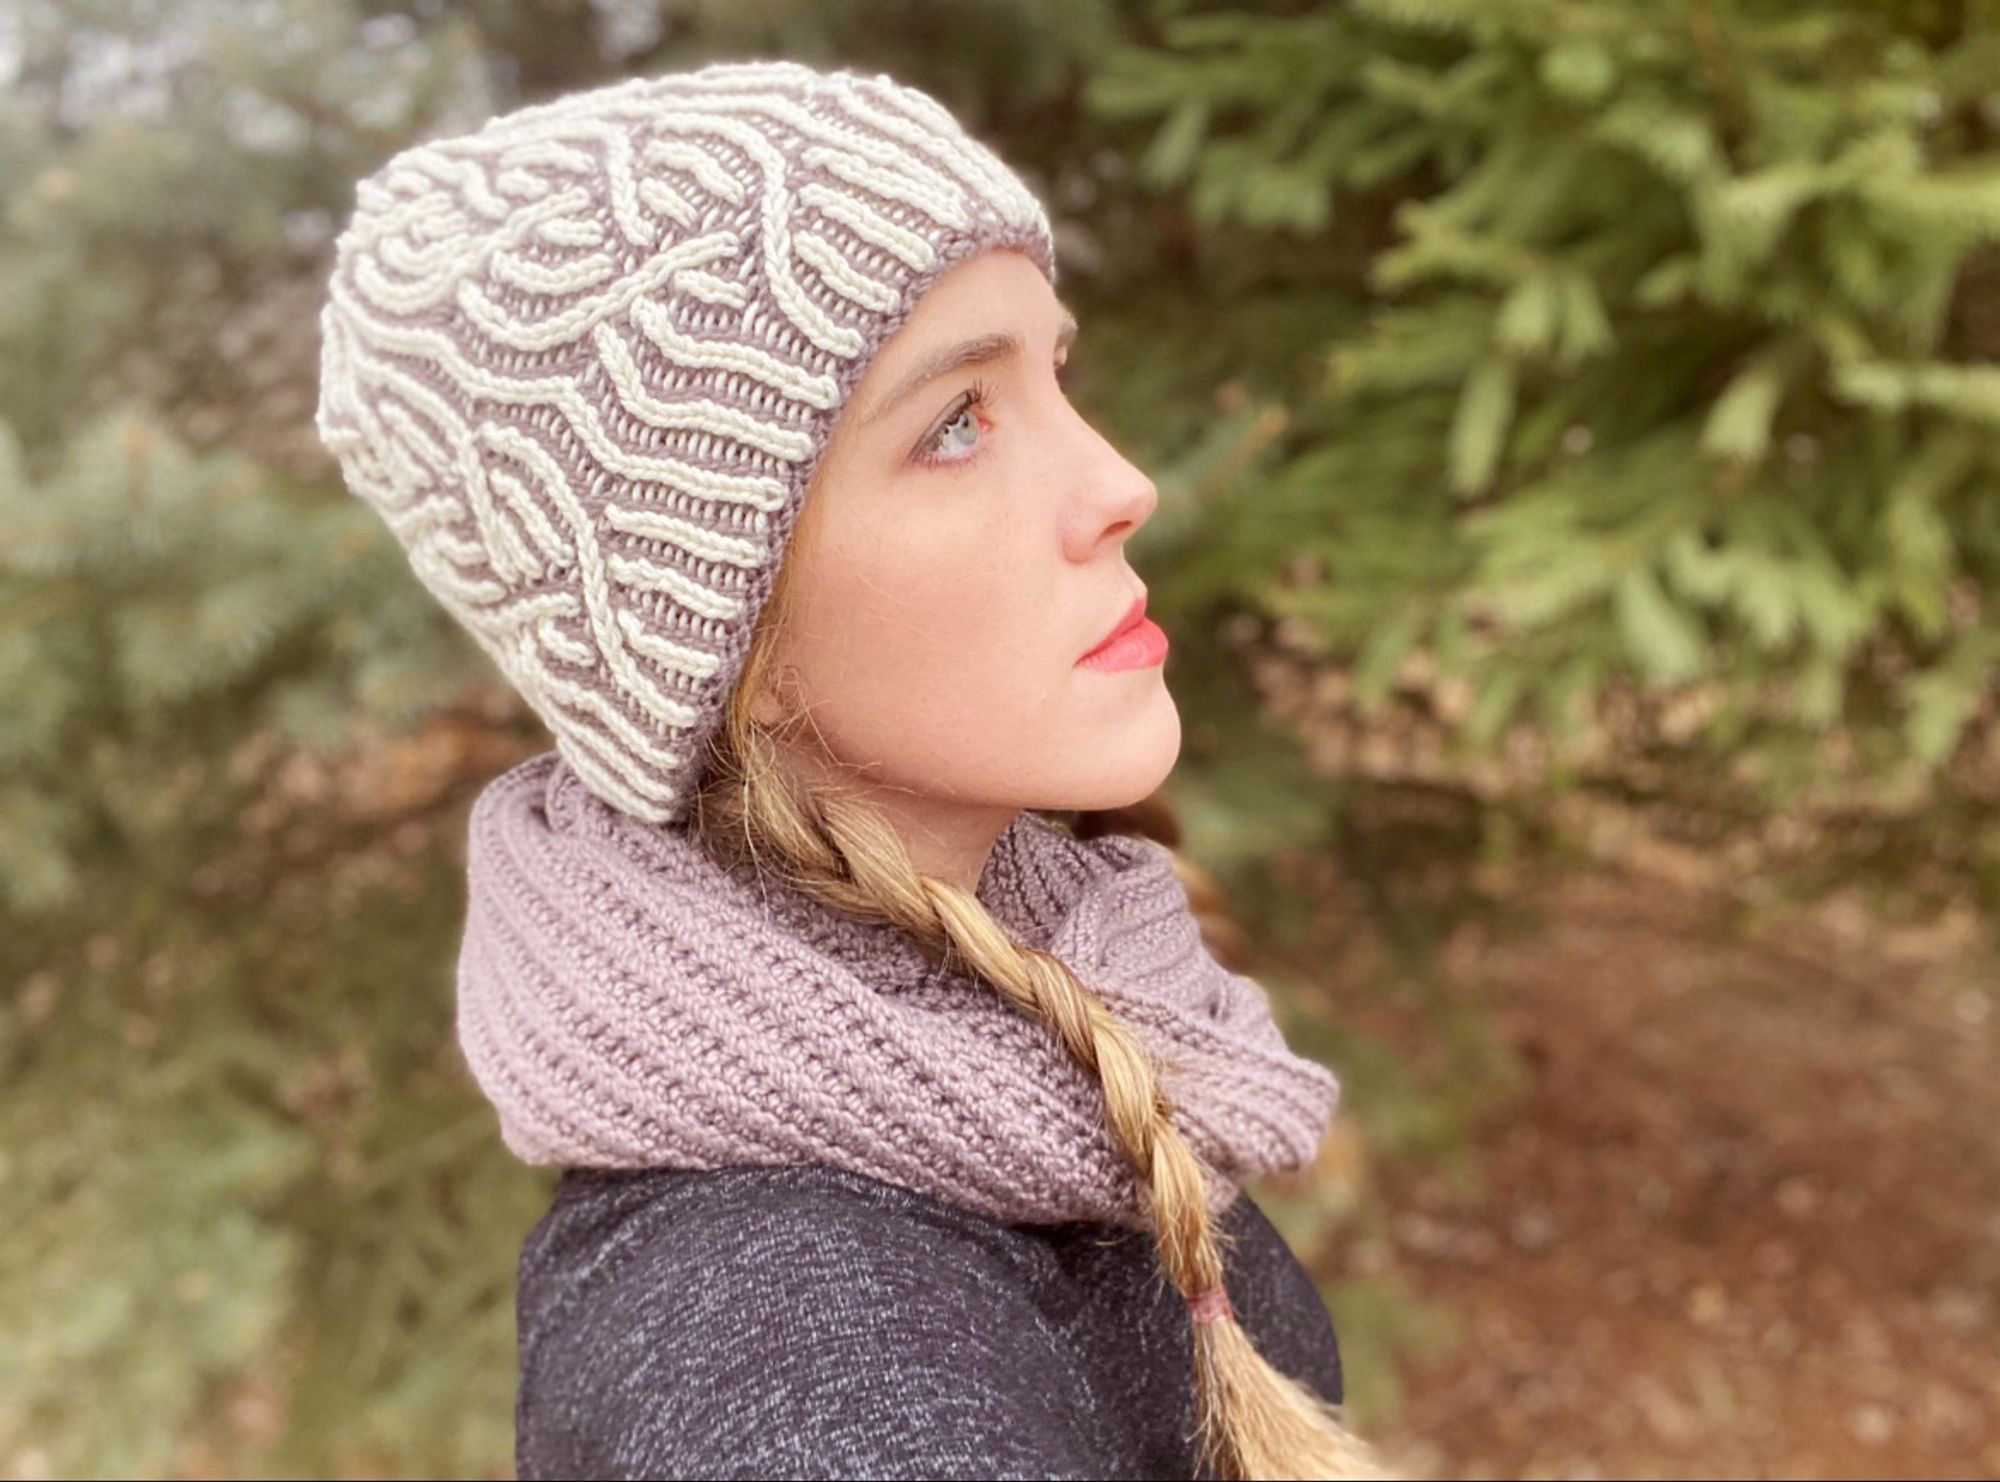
[516,1164,1340,1482]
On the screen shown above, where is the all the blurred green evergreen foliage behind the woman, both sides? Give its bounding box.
[11,0,2000,1476]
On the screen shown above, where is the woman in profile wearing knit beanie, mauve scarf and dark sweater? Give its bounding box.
[318,52,1368,1478]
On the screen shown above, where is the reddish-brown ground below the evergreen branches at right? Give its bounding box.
[1332,870,2000,1478]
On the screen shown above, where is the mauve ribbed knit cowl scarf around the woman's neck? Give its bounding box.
[458,752,1338,1228]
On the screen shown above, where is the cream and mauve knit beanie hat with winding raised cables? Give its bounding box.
[316,62,1056,824]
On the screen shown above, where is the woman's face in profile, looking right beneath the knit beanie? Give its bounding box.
[756,250,1180,888]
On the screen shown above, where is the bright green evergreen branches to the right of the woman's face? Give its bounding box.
[1090,0,2000,800]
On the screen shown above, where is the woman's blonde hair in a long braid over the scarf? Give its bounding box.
[690,488,1388,1482]
